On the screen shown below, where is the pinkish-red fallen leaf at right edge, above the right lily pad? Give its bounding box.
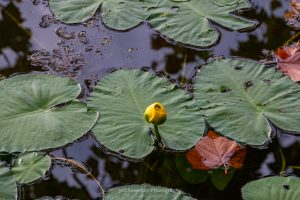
[276,45,300,81]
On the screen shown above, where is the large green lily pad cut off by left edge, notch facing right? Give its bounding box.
[0,74,98,152]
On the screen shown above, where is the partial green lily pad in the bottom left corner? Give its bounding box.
[0,162,17,200]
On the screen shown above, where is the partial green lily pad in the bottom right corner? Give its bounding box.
[242,176,300,200]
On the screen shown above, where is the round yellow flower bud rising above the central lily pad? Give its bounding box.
[144,102,167,125]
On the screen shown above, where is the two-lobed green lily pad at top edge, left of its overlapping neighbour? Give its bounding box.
[49,0,159,30]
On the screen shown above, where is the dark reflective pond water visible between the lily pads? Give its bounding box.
[0,0,300,199]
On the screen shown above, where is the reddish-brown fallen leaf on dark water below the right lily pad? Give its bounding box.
[186,131,246,173]
